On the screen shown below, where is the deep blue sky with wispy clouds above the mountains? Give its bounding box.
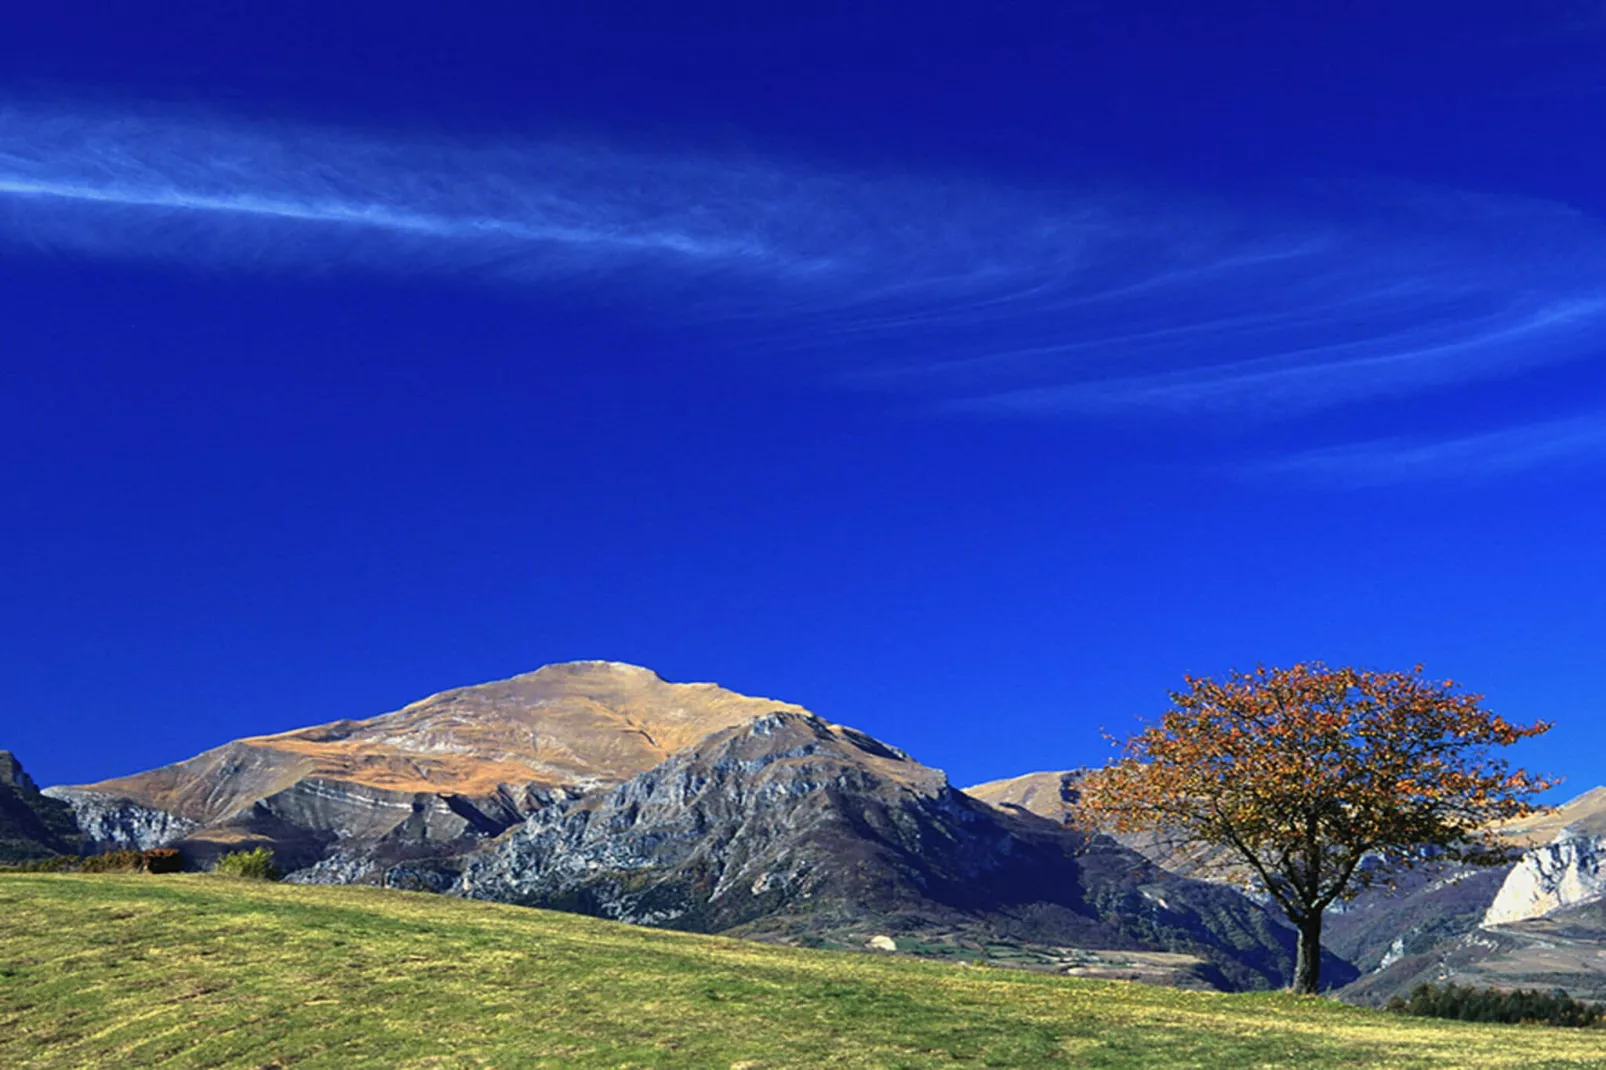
[0,3,1606,794]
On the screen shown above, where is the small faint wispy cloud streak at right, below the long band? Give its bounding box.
[1249,411,1606,487]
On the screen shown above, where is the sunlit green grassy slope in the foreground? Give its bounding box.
[0,874,1606,1070]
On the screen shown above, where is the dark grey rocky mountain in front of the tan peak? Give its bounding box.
[450,712,1344,988]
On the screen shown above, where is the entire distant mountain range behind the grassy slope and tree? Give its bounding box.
[15,662,1606,998]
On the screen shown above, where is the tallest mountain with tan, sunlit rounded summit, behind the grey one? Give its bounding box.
[51,662,801,868]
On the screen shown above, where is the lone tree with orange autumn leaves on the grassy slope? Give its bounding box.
[1079,662,1556,993]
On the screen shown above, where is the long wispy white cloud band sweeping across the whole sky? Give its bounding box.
[0,98,1606,419]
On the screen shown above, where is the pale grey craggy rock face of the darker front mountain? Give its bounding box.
[453,713,952,927]
